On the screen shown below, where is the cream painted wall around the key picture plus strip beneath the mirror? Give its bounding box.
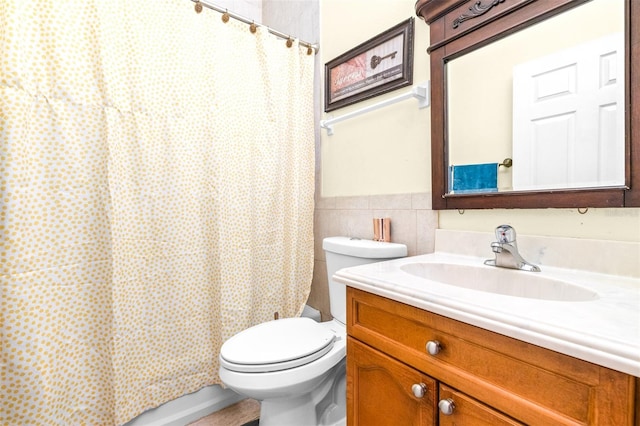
[318,0,640,243]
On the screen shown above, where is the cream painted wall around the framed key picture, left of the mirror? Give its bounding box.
[319,0,430,197]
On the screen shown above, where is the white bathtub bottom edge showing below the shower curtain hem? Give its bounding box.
[124,385,244,426]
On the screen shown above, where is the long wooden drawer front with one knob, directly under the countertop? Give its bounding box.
[347,287,634,425]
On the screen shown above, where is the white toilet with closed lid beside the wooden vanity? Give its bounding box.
[220,237,407,426]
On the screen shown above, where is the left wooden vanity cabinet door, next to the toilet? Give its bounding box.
[347,337,437,426]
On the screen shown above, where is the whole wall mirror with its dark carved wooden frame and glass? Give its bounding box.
[416,0,640,209]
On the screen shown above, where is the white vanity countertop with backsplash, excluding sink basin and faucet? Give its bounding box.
[334,230,640,377]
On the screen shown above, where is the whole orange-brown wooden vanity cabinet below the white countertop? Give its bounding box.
[347,287,638,426]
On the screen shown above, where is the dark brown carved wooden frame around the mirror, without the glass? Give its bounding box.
[415,0,640,210]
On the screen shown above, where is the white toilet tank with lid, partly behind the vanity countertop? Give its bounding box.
[322,237,407,324]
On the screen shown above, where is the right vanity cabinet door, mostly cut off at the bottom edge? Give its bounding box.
[438,384,523,426]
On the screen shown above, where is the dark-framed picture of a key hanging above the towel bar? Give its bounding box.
[324,18,414,111]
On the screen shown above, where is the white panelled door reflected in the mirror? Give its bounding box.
[513,34,625,190]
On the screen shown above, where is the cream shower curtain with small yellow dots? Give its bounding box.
[0,0,314,425]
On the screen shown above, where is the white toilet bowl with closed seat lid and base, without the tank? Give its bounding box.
[220,318,346,426]
